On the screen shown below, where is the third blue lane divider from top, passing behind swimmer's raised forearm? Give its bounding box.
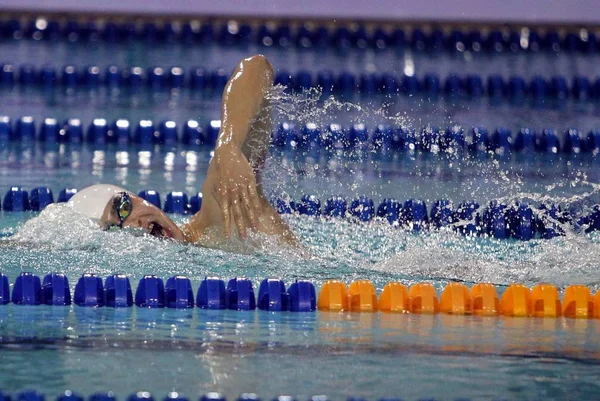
[7,117,600,157]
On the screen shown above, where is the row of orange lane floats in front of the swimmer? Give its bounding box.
[317,280,600,319]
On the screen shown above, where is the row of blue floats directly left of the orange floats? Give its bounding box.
[0,272,316,312]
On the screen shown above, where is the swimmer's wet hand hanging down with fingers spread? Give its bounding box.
[207,144,262,239]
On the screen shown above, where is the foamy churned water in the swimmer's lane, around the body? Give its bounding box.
[0,204,600,289]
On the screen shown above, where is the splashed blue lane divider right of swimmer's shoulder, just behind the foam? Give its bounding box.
[274,195,600,241]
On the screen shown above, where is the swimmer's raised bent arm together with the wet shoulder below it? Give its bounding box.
[183,56,301,248]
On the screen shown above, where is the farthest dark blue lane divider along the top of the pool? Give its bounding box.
[0,16,598,54]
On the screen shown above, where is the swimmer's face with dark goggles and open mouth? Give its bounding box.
[100,193,184,241]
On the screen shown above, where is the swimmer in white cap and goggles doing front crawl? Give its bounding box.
[69,55,299,248]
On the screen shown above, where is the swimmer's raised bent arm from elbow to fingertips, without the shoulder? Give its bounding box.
[207,55,273,238]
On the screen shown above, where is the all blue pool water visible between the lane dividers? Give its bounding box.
[0,20,600,400]
